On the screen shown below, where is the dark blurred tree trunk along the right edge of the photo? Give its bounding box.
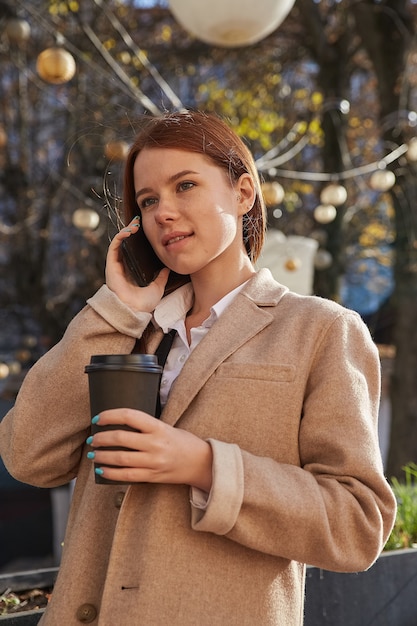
[352,0,417,476]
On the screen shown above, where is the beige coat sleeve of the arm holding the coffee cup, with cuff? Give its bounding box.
[192,312,396,571]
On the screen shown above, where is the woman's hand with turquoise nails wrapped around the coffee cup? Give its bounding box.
[87,409,213,492]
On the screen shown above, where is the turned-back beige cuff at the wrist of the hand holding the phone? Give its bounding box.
[87,285,152,338]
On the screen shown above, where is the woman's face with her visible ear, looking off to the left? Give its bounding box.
[133,148,253,274]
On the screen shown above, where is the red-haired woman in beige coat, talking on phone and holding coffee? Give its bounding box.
[1,112,395,626]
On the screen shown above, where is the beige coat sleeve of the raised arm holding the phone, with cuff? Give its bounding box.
[0,285,151,487]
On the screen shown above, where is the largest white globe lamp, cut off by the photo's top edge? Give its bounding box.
[169,0,295,48]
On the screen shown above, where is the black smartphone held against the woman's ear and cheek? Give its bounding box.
[122,228,190,296]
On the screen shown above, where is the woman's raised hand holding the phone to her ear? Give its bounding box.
[106,217,169,313]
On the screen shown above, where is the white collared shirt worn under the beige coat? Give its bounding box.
[153,281,247,406]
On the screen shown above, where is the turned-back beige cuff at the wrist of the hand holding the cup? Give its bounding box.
[191,439,244,535]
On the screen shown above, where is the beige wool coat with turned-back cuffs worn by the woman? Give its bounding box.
[0,269,395,626]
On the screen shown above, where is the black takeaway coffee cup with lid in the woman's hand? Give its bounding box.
[85,354,162,485]
